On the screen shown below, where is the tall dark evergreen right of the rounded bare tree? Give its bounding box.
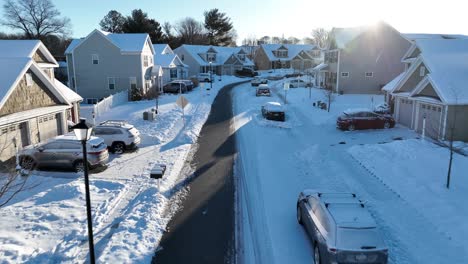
[204,8,236,46]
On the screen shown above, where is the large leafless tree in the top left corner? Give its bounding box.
[1,0,70,39]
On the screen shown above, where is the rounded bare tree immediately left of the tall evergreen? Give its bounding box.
[174,17,208,44]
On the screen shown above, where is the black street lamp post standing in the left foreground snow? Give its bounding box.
[72,118,95,264]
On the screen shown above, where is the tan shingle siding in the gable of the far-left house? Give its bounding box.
[0,70,60,116]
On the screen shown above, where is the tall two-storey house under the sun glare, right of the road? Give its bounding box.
[314,22,411,94]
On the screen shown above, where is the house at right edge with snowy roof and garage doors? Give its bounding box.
[389,38,468,141]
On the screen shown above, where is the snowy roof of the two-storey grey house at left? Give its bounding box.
[65,29,153,54]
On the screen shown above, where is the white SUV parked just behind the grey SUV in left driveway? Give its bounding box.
[93,120,141,154]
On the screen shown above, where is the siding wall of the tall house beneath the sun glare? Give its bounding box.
[331,25,410,94]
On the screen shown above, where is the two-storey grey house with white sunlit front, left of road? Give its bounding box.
[65,29,154,103]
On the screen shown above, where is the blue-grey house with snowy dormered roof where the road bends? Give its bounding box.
[174,45,254,76]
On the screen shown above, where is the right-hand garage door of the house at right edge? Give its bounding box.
[416,103,442,139]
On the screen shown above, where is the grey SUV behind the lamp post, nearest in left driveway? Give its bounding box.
[18,133,109,172]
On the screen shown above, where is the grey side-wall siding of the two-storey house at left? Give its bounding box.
[73,32,144,99]
